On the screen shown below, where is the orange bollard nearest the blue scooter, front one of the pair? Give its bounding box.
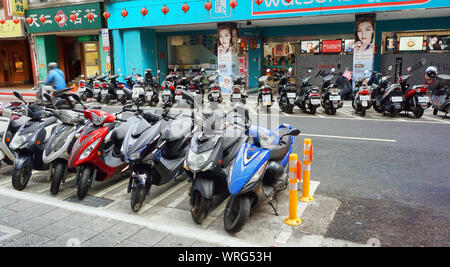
[284,154,302,226]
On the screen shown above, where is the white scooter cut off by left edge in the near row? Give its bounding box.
[0,101,29,165]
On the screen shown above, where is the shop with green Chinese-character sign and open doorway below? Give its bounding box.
[26,2,110,82]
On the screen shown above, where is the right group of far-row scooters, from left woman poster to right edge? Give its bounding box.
[258,60,450,118]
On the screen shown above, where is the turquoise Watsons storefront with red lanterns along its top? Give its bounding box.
[106,0,450,91]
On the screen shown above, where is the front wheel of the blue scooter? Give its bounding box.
[223,196,250,234]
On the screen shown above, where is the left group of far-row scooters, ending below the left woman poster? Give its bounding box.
[74,69,248,108]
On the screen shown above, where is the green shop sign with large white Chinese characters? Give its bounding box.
[26,3,102,33]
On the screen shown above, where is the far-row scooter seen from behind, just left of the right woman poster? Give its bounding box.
[316,68,344,115]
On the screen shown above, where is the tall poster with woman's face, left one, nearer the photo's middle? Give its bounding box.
[217,23,239,94]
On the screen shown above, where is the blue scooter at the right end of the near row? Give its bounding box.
[223,124,300,234]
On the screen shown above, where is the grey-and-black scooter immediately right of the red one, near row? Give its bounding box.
[121,92,194,212]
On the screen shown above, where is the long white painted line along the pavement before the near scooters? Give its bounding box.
[0,188,261,247]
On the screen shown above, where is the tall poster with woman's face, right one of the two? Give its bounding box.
[353,14,376,87]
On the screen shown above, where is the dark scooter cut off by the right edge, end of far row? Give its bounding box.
[431,74,450,117]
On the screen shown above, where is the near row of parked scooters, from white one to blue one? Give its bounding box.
[0,90,300,233]
